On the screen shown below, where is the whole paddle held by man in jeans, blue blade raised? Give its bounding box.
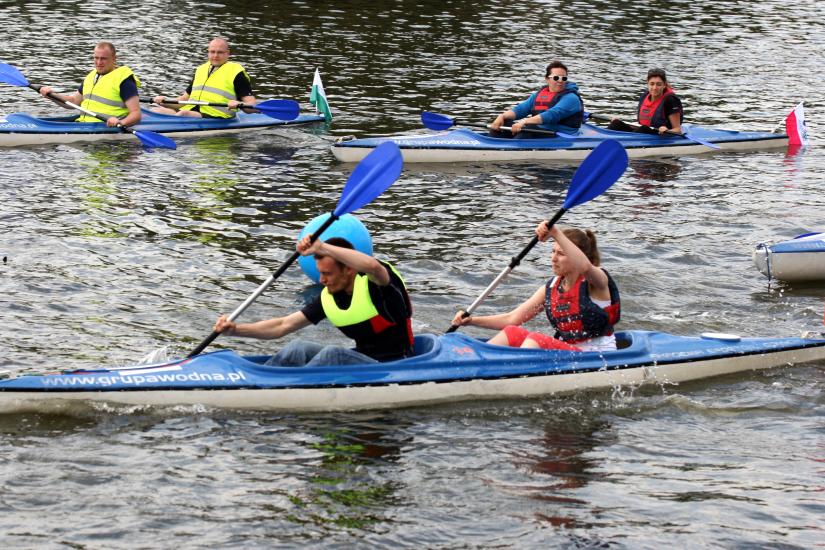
[187,141,404,357]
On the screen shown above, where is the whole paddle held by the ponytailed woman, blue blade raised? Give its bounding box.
[447,139,627,333]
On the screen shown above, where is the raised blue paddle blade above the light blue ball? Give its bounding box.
[333,141,404,216]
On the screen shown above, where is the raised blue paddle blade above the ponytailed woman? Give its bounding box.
[564,139,627,210]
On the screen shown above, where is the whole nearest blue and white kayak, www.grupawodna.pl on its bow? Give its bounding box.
[0,331,825,412]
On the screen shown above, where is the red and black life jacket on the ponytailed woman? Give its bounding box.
[544,269,621,343]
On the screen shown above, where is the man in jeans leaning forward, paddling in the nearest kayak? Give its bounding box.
[215,236,413,366]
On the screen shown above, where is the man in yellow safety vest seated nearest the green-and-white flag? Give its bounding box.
[152,38,255,118]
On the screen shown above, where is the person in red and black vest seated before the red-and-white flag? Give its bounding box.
[608,69,684,134]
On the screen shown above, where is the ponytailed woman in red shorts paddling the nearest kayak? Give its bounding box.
[453,220,621,351]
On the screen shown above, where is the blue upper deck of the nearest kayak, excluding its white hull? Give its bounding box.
[6,331,825,392]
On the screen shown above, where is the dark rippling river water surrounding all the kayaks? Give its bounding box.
[0,0,825,548]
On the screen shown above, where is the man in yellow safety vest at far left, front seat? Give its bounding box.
[40,42,140,126]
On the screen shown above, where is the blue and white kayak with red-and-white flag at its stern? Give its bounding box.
[332,124,788,162]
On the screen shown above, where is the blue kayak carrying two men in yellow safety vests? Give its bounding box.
[0,109,324,147]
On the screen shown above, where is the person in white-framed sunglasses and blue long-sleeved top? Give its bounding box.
[491,61,584,138]
